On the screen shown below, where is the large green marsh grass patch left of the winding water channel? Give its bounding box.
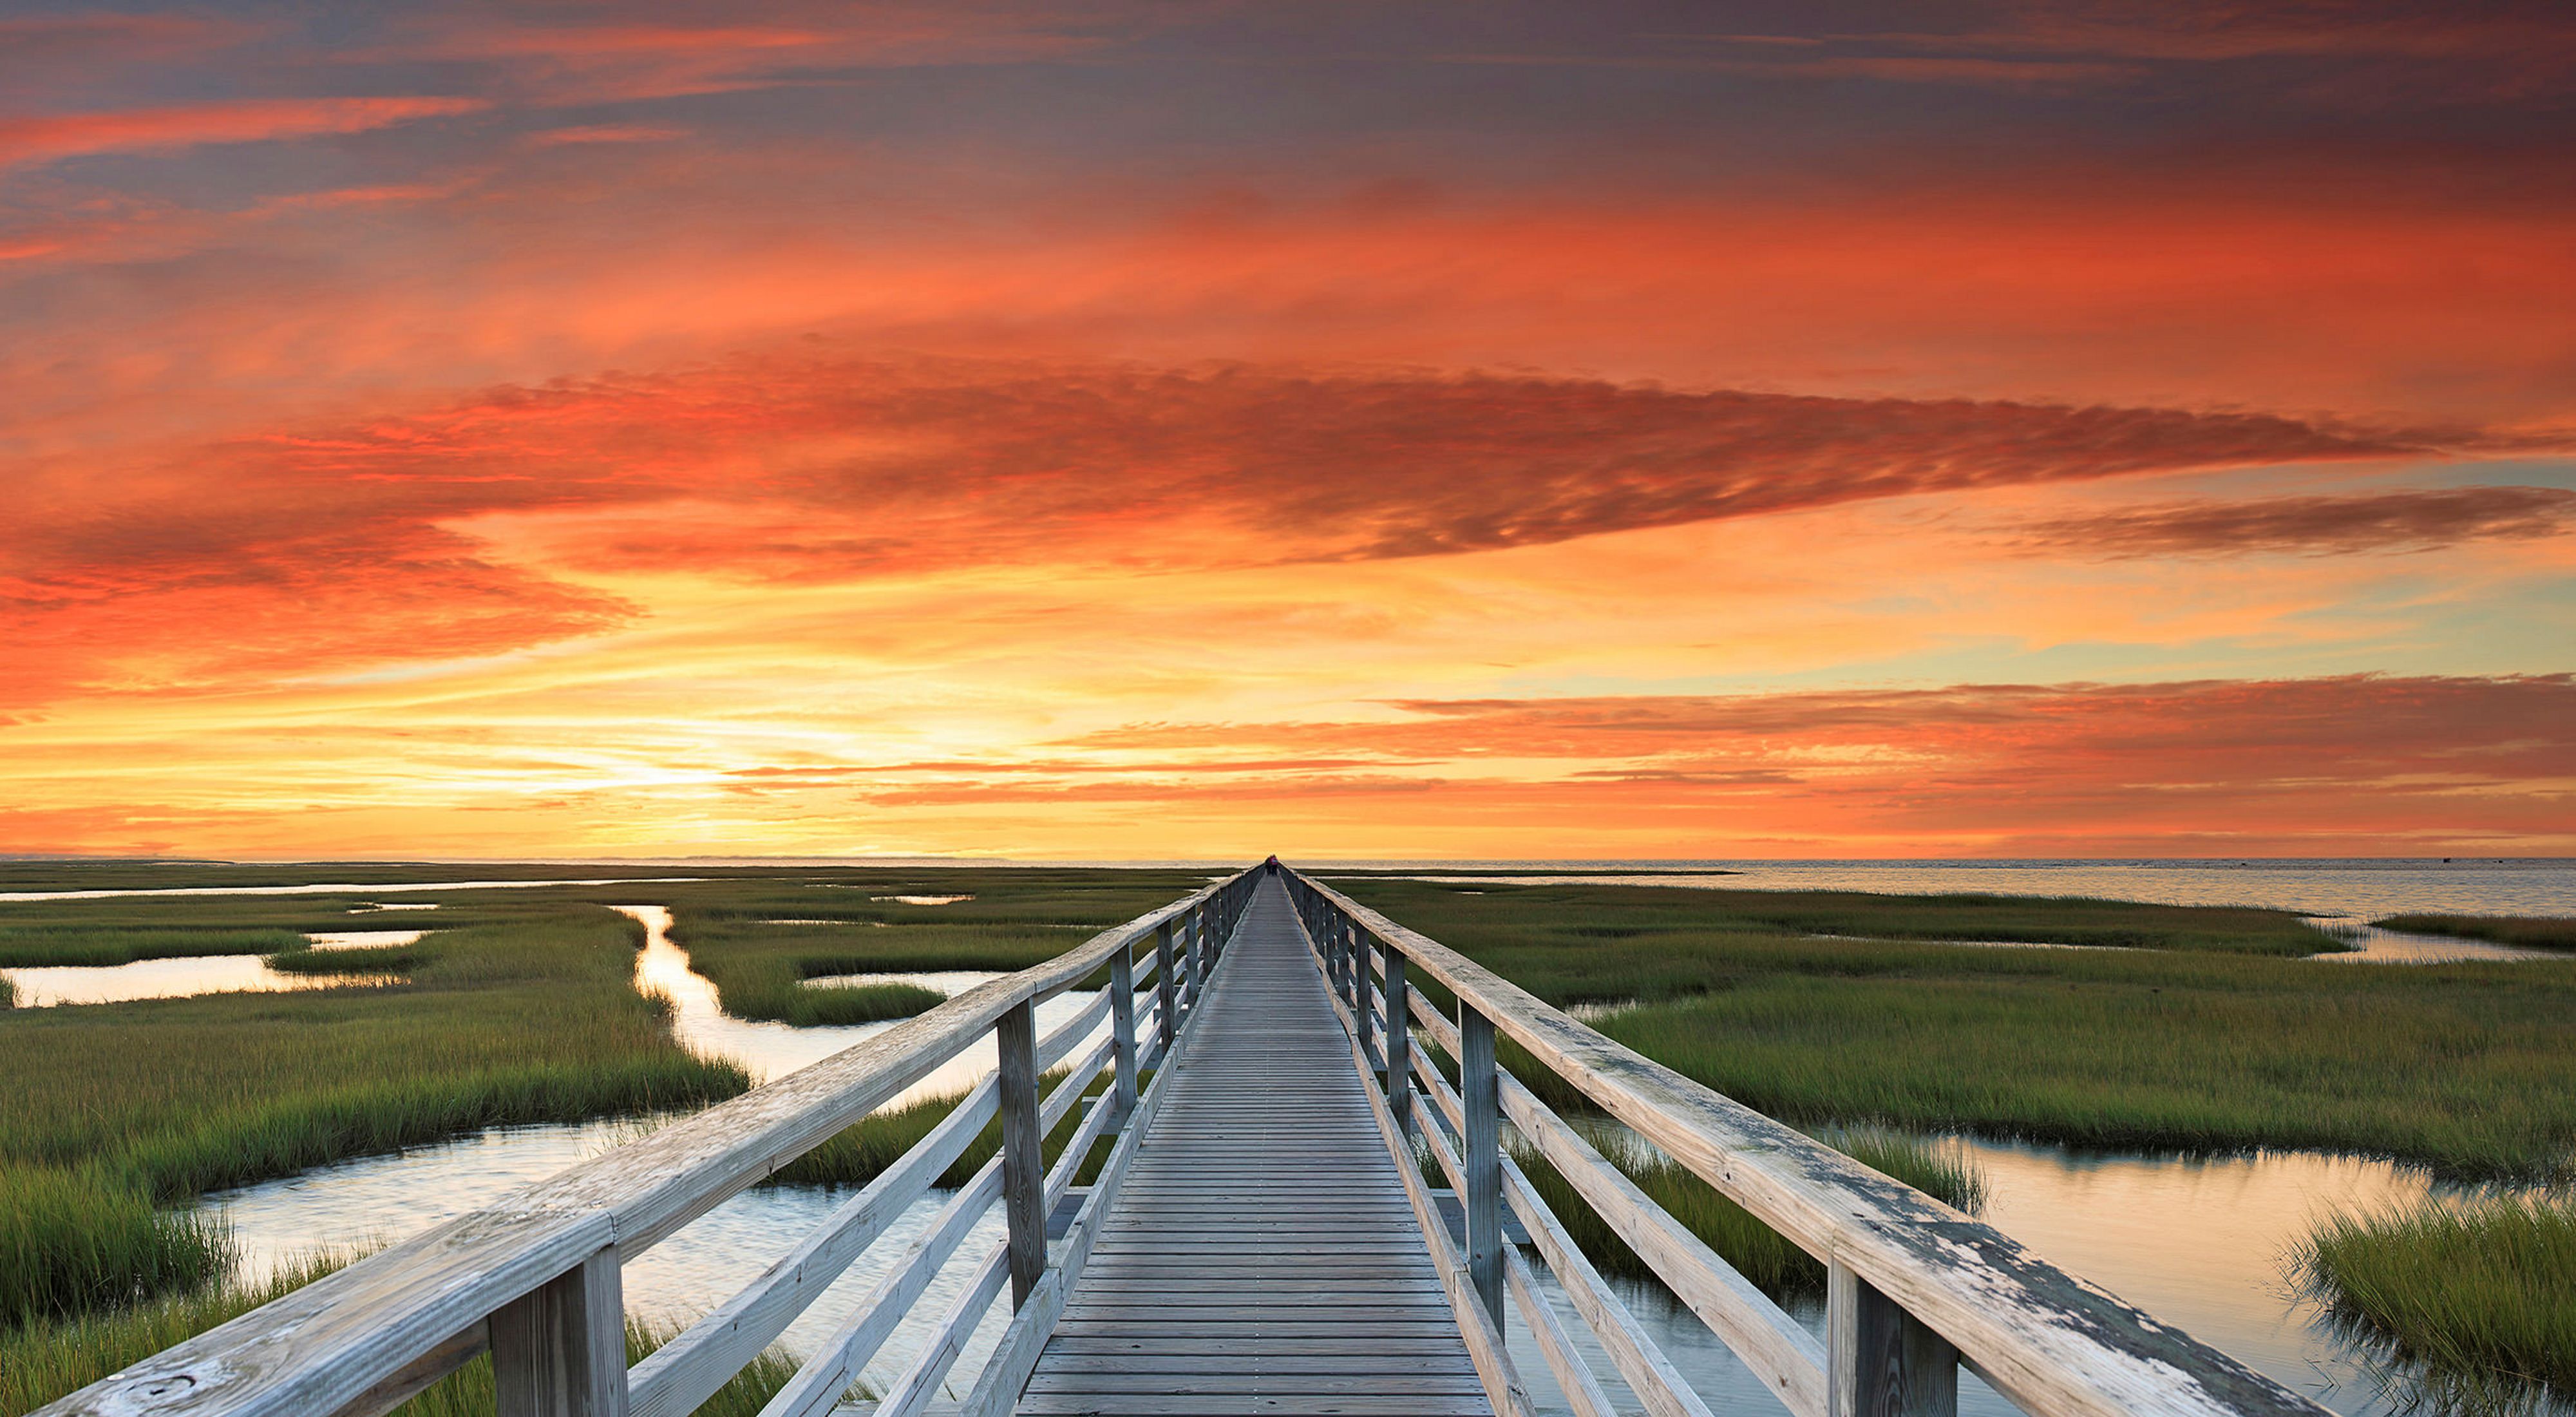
[0,902,747,1327]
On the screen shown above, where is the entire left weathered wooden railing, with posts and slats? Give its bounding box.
[41,871,1257,1417]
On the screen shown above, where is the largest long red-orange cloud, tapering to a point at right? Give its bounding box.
[0,353,2494,706]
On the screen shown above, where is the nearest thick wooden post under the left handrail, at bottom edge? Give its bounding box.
[489,1247,626,1417]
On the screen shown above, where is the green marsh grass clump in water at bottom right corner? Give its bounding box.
[2295,1195,2576,1407]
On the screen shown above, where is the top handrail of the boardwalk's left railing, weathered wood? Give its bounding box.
[53,866,1262,1417]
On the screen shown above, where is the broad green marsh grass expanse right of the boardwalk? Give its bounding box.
[1350,881,2576,1180]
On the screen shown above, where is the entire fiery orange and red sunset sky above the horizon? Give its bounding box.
[0,0,2576,858]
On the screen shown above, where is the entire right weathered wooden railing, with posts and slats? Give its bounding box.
[1283,871,2324,1417]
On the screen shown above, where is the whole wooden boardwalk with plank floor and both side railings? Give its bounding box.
[36,858,2329,1417]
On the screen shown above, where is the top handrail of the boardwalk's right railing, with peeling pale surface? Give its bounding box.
[1283,866,2324,1417]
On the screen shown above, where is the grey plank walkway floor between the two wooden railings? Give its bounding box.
[1018,881,1492,1417]
